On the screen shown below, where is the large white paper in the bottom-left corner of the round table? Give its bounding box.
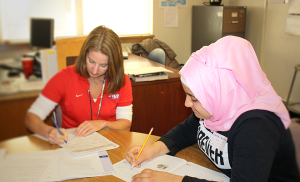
[0,148,115,182]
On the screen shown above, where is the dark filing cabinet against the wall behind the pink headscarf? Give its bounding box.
[192,6,247,52]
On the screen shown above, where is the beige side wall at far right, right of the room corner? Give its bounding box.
[261,3,300,102]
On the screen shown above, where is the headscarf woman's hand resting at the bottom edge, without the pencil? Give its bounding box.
[132,169,183,182]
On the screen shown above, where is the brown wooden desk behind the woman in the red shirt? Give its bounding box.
[0,53,192,141]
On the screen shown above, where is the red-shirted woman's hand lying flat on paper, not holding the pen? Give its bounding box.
[75,120,106,137]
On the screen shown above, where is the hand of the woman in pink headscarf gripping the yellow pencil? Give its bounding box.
[125,145,155,167]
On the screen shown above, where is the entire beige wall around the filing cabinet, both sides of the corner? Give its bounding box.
[153,0,300,101]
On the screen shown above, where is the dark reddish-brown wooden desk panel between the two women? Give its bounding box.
[131,79,192,136]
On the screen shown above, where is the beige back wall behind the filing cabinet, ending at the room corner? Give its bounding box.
[153,0,265,63]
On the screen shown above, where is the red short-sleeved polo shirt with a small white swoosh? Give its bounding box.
[42,65,132,128]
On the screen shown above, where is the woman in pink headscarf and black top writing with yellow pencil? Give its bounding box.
[126,36,300,182]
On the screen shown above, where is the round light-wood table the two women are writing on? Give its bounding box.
[0,130,220,182]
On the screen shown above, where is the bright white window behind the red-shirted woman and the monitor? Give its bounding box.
[0,0,152,42]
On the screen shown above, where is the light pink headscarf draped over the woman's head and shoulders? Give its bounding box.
[179,36,291,131]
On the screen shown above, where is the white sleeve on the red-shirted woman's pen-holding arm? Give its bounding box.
[27,94,57,120]
